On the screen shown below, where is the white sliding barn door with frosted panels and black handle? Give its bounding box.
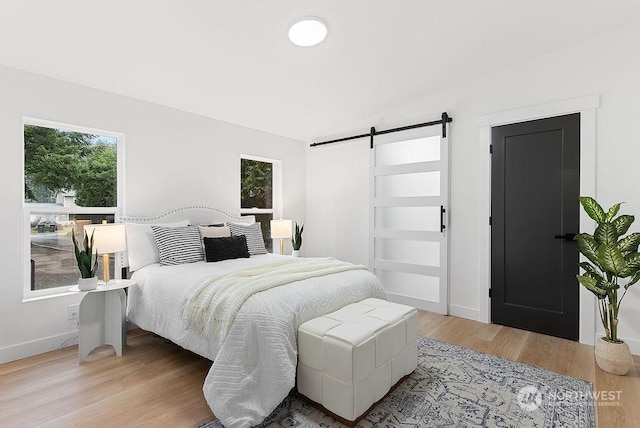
[369,126,449,314]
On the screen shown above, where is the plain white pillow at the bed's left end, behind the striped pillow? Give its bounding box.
[124,220,189,271]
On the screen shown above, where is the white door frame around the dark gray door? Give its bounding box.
[476,94,600,345]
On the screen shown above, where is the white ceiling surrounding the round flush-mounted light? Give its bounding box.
[0,0,640,141]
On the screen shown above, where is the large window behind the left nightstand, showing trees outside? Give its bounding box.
[24,119,123,297]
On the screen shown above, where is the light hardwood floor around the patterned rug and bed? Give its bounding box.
[0,312,640,428]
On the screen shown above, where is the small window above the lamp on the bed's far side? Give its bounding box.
[240,155,282,252]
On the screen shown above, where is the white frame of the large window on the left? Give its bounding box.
[21,117,125,302]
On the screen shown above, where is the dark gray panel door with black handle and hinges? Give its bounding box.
[491,113,580,340]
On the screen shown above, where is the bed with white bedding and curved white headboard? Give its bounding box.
[121,207,385,427]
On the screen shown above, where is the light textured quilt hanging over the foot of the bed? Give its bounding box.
[202,264,386,428]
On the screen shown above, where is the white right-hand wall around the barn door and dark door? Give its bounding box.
[305,21,640,354]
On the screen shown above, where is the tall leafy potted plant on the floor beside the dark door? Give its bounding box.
[576,196,640,375]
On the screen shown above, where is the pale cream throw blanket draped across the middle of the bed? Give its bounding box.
[183,258,367,342]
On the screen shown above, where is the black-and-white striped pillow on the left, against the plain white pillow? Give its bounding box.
[151,225,204,265]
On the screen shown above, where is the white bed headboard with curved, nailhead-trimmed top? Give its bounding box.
[115,206,255,277]
